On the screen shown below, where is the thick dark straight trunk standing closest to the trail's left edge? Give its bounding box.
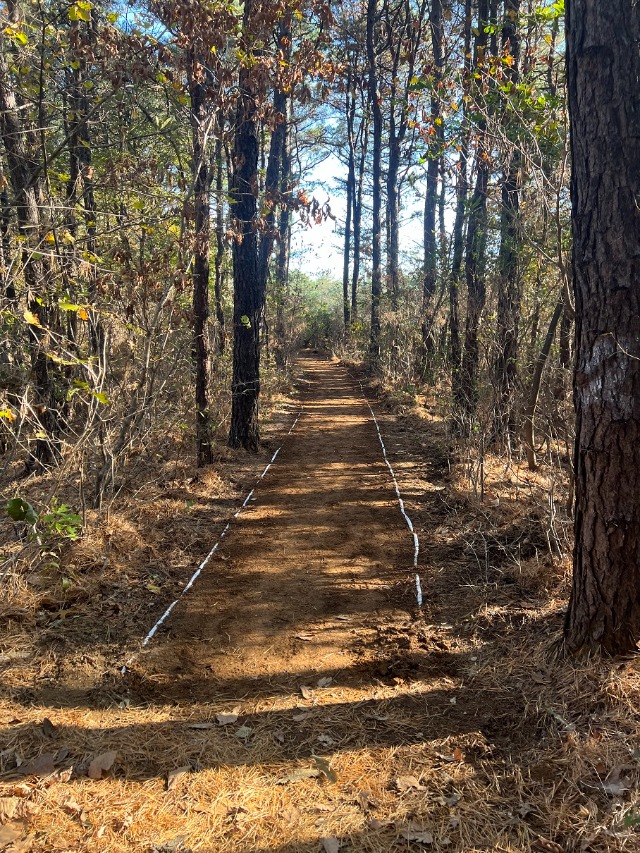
[229,0,265,450]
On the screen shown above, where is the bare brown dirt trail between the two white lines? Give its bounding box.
[145,356,413,698]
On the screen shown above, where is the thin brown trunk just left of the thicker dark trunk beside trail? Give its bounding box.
[189,51,213,468]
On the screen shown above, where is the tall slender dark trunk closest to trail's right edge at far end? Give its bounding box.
[367,0,382,373]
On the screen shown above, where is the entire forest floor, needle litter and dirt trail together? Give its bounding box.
[0,354,640,853]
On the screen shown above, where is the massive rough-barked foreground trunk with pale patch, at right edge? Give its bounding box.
[565,0,640,654]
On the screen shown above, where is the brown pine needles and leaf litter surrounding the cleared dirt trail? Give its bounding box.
[0,362,640,853]
